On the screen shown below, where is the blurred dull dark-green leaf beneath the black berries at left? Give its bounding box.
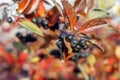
[13,42,30,51]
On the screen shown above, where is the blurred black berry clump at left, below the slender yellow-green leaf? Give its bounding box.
[16,32,37,44]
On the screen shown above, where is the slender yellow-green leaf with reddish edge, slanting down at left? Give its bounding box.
[20,20,44,36]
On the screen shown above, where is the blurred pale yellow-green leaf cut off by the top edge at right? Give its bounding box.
[98,0,115,10]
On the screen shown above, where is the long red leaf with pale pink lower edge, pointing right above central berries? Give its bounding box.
[77,18,106,34]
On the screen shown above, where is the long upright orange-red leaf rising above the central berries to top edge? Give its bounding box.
[62,1,76,31]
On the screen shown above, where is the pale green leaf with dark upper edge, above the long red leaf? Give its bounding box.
[88,9,110,19]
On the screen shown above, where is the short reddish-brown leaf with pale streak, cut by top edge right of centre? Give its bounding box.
[74,0,86,13]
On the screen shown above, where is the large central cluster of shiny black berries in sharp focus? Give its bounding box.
[56,33,89,57]
